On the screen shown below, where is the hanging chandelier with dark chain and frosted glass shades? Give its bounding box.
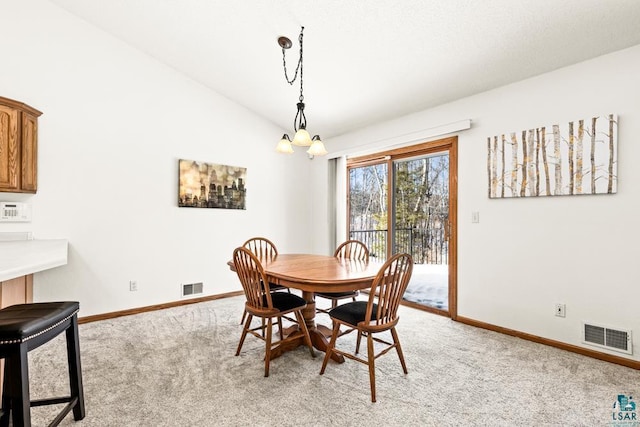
[276,27,327,156]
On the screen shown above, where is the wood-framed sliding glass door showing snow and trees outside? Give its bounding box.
[347,138,457,318]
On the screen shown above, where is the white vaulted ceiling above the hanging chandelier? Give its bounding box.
[50,0,640,138]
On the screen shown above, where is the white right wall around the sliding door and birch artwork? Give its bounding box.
[312,46,640,360]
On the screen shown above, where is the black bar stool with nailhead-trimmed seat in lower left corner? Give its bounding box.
[0,302,85,427]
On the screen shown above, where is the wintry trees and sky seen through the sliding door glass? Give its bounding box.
[349,156,449,264]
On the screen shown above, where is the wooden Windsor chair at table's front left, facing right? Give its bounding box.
[233,247,316,377]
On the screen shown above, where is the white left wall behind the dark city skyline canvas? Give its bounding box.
[0,0,311,316]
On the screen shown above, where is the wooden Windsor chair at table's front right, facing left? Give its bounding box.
[320,254,413,402]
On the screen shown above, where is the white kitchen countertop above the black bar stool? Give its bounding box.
[0,239,68,282]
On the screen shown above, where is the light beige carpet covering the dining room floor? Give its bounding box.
[29,297,640,427]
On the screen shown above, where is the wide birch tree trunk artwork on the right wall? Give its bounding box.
[487,114,618,198]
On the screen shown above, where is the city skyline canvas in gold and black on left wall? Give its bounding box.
[178,159,247,209]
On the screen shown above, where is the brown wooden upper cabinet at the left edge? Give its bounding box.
[0,97,42,193]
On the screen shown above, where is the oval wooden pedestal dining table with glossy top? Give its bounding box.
[228,254,382,363]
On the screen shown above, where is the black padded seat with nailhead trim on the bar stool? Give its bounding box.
[0,301,80,343]
